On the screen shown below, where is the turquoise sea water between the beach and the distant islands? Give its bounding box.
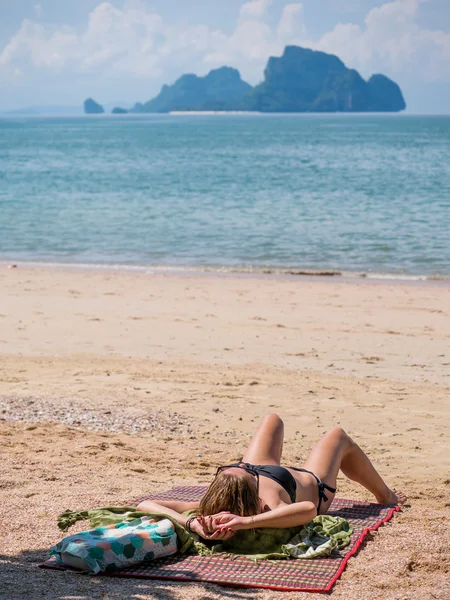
[0,115,450,276]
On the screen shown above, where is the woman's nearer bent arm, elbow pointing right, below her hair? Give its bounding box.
[206,502,317,531]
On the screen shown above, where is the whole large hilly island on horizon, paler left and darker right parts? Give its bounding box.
[136,46,406,113]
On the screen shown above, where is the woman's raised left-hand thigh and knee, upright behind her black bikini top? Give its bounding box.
[242,414,284,465]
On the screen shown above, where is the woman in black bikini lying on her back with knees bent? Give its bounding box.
[138,414,406,540]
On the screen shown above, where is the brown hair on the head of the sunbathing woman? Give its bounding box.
[198,471,260,517]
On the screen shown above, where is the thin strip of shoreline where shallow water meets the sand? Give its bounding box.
[0,259,450,287]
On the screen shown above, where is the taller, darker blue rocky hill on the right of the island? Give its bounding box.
[243,46,406,112]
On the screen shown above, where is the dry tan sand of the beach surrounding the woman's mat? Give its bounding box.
[0,265,450,600]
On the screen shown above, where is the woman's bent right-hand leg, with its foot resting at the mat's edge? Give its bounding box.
[305,427,406,508]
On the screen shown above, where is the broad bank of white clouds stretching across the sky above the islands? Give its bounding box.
[0,0,450,99]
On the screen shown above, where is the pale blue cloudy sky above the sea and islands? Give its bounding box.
[0,0,450,114]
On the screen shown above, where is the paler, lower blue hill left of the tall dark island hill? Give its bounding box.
[141,67,252,113]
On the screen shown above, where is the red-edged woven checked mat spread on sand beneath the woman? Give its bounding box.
[39,486,400,592]
